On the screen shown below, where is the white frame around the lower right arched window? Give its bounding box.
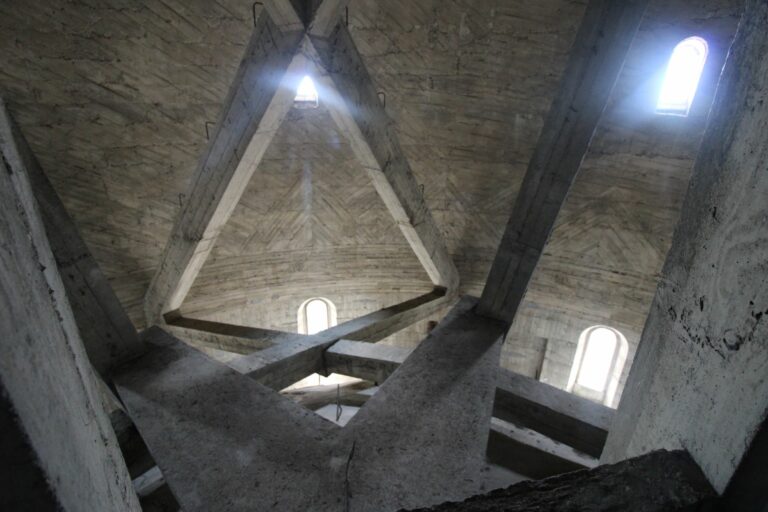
[566,325,629,407]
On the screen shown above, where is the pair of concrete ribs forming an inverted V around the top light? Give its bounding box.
[144,0,459,325]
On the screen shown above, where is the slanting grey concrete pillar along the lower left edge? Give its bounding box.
[0,105,140,512]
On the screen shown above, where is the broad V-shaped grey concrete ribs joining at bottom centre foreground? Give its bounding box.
[115,299,505,512]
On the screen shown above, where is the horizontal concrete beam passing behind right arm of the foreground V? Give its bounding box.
[325,340,614,457]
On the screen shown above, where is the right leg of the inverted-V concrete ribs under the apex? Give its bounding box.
[309,26,459,293]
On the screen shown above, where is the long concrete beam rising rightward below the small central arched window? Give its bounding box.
[227,290,455,389]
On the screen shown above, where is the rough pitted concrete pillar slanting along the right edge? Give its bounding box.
[603,0,768,491]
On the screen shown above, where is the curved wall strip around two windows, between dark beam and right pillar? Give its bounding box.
[502,0,743,407]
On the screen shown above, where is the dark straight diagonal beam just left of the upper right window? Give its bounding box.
[478,0,648,324]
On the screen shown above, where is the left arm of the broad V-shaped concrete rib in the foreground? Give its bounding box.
[115,327,342,512]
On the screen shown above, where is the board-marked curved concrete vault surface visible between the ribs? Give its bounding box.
[0,0,739,400]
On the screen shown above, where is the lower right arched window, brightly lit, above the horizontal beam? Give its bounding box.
[567,325,628,406]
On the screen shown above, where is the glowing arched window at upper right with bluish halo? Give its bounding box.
[656,37,707,116]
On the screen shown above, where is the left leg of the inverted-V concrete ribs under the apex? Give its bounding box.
[144,12,306,325]
